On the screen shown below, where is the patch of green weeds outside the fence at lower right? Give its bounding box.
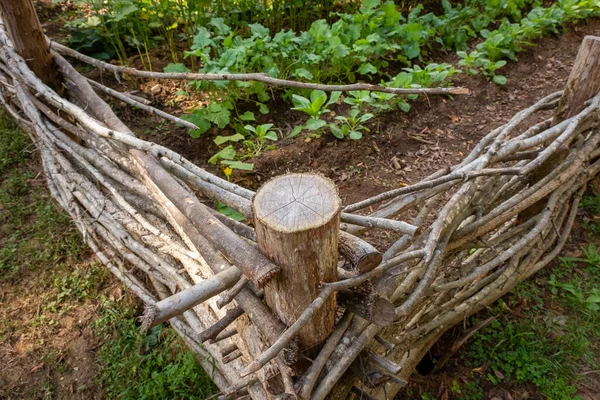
[459,244,600,399]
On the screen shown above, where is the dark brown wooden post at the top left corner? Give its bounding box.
[0,0,62,90]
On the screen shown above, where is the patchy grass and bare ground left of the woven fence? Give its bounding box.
[0,112,216,399]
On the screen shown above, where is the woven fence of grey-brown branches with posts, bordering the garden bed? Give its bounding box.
[0,4,600,399]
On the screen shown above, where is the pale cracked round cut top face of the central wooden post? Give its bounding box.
[253,174,340,233]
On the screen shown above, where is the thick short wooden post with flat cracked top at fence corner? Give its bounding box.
[252,174,340,349]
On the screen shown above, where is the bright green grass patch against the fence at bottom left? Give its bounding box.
[96,298,216,400]
